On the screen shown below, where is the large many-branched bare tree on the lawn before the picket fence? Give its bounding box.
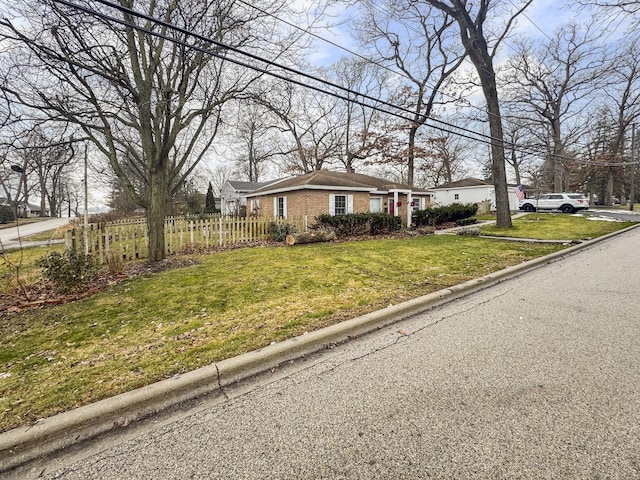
[0,0,292,261]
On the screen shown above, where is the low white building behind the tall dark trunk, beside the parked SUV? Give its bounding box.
[429,178,520,210]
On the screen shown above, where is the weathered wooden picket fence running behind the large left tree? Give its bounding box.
[65,215,308,263]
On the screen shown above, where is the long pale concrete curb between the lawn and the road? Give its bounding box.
[0,224,640,473]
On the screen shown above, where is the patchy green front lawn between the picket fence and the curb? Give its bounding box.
[0,216,636,431]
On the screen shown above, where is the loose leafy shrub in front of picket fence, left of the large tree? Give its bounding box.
[36,249,98,292]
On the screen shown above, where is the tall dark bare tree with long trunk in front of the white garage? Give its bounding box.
[425,0,533,228]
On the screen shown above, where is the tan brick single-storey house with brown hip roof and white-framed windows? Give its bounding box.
[246,170,431,225]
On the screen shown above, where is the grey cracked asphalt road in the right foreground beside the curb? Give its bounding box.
[17,229,640,480]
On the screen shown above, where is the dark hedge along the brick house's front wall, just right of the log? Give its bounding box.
[314,213,402,236]
